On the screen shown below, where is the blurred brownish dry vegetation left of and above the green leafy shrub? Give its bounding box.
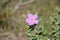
[0,0,60,40]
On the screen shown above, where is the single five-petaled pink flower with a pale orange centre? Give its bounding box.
[26,14,38,25]
